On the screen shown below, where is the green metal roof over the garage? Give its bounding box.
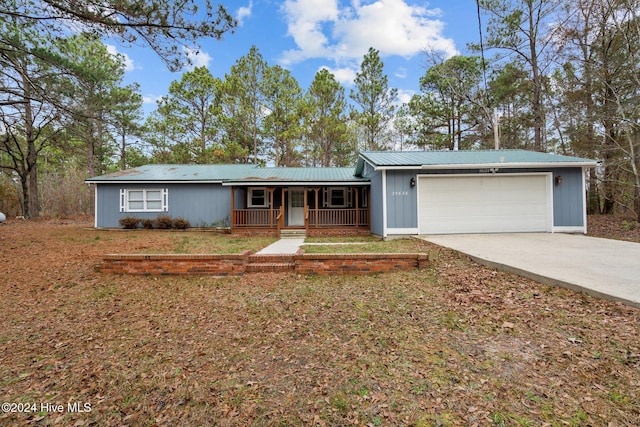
[356,150,596,174]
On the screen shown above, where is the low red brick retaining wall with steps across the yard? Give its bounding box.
[95,251,429,276]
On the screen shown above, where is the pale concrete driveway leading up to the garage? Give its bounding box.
[421,233,640,308]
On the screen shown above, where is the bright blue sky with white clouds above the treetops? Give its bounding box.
[109,0,479,113]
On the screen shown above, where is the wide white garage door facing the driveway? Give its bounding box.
[418,174,552,234]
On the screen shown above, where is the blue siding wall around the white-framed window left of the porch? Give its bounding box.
[96,184,231,228]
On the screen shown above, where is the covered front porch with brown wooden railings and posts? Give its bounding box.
[230,183,370,236]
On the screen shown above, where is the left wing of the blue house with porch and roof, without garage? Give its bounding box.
[86,165,370,235]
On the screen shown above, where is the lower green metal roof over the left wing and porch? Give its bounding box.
[86,165,368,185]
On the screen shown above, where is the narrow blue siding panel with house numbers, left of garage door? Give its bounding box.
[387,170,418,228]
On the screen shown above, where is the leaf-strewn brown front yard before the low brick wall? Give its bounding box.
[0,221,640,426]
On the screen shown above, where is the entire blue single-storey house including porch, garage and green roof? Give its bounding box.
[86,150,596,237]
